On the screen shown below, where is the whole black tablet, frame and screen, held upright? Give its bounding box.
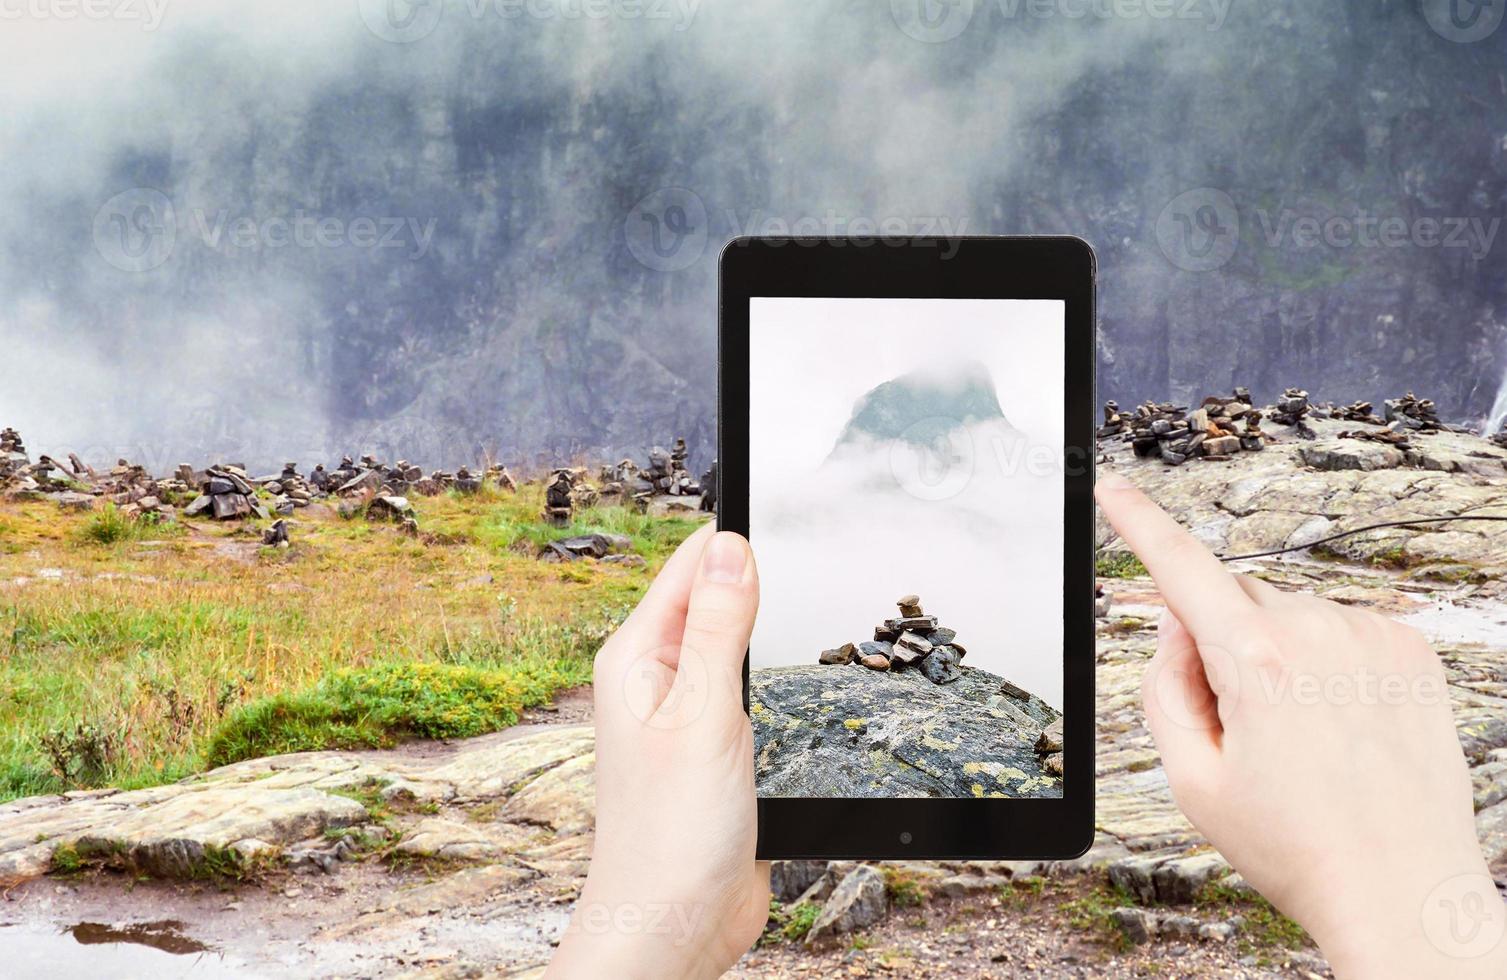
[719,238,1094,859]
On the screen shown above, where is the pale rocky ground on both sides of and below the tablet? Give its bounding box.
[0,419,1507,977]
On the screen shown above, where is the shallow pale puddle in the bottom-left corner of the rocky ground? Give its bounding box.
[0,921,249,980]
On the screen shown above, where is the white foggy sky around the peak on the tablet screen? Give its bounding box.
[749,297,1064,707]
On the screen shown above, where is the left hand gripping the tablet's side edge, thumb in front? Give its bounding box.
[547,528,769,978]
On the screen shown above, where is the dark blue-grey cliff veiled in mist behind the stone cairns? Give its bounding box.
[0,0,1507,469]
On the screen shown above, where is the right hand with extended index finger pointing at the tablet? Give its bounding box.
[1096,473,1507,977]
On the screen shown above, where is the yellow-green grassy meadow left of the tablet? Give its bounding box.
[0,484,701,801]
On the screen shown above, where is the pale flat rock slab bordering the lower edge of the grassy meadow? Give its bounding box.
[0,727,595,880]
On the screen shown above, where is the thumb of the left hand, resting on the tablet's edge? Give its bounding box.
[662,531,758,712]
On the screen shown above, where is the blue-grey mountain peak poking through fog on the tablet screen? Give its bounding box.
[836,360,1008,446]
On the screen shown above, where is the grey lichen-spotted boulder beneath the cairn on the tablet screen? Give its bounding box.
[749,665,1062,798]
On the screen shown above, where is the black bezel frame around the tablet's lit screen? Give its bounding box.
[717,237,1096,859]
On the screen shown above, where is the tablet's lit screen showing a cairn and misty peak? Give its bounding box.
[747,297,1065,799]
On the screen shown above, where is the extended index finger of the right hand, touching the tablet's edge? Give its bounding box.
[1094,473,1255,639]
